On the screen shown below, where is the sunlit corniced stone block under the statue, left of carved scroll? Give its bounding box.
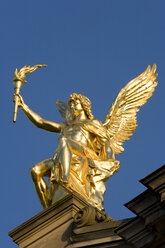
[9,194,88,248]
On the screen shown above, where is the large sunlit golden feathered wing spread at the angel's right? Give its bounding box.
[103,64,157,154]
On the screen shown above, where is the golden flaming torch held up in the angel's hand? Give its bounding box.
[13,65,47,122]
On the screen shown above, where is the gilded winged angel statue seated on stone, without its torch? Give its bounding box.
[14,65,157,210]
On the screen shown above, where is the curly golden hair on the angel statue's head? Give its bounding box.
[68,93,94,120]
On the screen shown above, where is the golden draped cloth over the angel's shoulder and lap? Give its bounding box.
[50,120,119,210]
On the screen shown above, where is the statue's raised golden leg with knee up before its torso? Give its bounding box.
[58,136,83,183]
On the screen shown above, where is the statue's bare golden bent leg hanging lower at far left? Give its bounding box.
[30,159,54,208]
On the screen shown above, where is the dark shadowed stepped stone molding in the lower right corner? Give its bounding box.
[116,165,165,248]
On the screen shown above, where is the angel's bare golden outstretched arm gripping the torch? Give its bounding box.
[14,95,65,133]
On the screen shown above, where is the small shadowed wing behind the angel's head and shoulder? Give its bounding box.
[56,100,73,122]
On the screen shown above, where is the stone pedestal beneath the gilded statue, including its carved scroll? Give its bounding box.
[9,193,130,248]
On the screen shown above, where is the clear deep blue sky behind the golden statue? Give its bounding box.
[0,0,165,248]
